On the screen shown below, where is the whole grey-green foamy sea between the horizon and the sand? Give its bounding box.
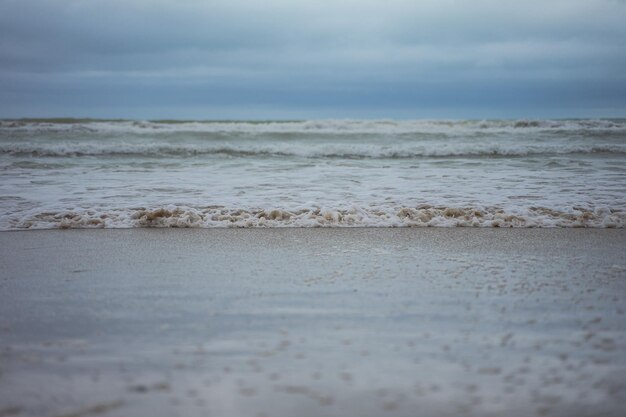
[0,119,626,230]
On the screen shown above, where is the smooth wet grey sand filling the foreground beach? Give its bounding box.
[0,228,626,417]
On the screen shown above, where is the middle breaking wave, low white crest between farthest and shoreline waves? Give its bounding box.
[0,141,626,159]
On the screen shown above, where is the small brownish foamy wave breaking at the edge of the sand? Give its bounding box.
[4,205,626,229]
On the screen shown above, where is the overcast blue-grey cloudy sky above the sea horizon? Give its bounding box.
[0,0,626,119]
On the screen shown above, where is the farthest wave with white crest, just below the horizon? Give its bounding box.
[0,119,626,134]
